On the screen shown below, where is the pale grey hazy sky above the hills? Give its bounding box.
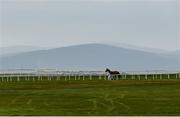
[0,0,180,50]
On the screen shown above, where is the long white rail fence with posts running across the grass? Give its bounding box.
[0,73,180,82]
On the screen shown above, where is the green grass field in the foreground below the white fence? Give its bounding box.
[0,79,180,116]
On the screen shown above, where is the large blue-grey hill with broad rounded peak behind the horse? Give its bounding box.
[0,44,180,71]
